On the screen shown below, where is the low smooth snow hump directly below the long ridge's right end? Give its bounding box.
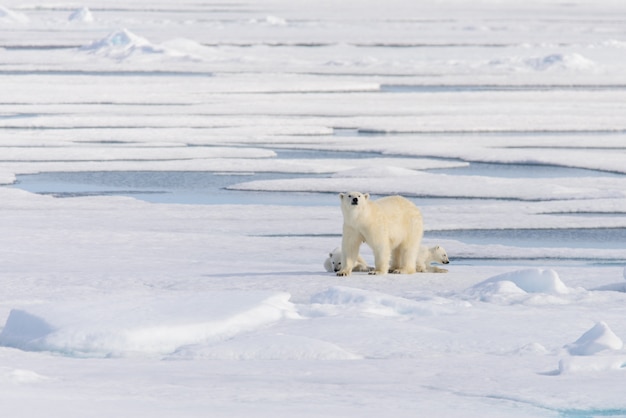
[168,334,362,360]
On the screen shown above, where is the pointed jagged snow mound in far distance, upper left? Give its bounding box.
[81,29,199,61]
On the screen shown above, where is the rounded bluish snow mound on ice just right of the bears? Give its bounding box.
[471,268,569,296]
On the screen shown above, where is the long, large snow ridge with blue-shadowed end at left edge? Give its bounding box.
[0,292,298,357]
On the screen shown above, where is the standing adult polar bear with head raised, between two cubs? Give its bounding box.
[337,192,426,276]
